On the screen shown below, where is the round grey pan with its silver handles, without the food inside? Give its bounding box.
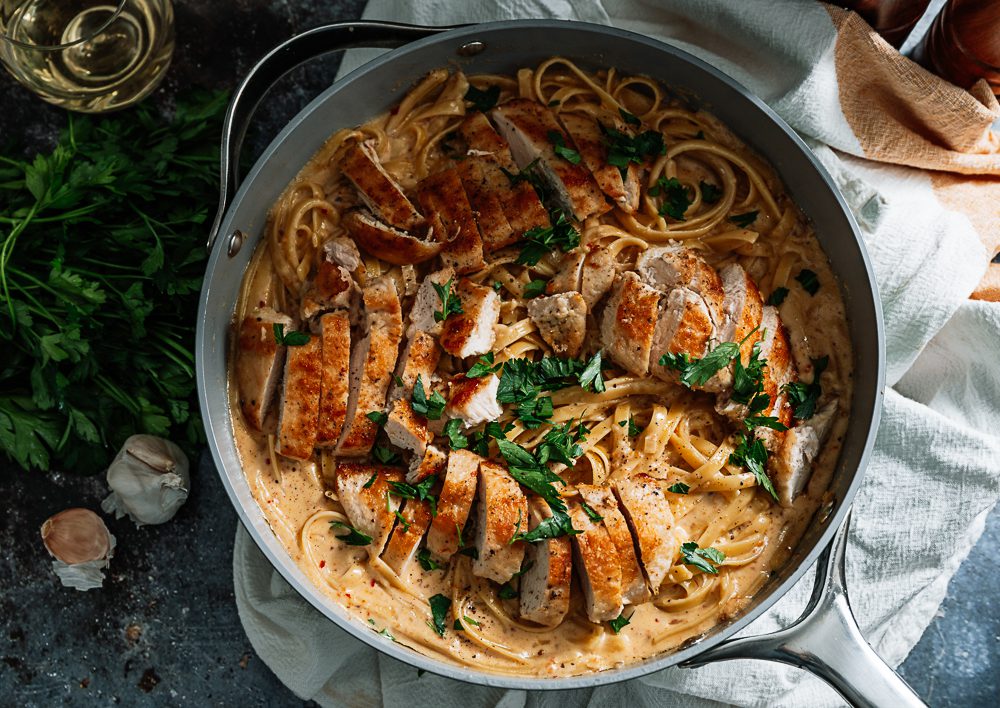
[197,20,921,706]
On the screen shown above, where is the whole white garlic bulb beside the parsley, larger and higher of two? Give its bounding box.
[101,435,191,526]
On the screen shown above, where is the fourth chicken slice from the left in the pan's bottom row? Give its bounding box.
[472,460,528,583]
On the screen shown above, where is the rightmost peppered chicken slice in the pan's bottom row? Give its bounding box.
[614,474,678,595]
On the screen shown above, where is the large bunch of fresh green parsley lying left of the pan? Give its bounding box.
[0,92,227,472]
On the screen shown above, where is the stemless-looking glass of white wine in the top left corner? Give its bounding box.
[0,0,174,113]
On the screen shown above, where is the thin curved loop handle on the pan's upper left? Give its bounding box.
[206,20,461,250]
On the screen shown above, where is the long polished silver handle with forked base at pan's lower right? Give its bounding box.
[682,515,924,708]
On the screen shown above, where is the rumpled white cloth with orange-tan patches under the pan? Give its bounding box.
[234,0,1000,706]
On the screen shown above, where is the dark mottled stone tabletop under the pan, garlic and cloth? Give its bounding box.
[0,0,1000,708]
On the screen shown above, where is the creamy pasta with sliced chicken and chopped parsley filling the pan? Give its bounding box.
[230,58,853,676]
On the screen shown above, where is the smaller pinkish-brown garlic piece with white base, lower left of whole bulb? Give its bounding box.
[42,509,115,590]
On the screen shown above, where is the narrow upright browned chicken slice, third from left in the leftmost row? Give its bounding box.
[316,312,351,447]
